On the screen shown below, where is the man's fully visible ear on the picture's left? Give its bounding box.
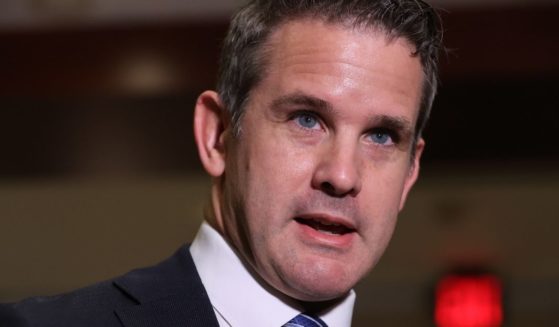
[194,91,227,177]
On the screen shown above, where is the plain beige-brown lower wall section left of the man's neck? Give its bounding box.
[0,176,208,301]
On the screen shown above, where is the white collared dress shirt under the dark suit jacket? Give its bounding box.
[190,222,355,327]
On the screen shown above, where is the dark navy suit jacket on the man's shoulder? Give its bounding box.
[7,246,218,327]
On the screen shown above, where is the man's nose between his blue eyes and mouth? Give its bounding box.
[312,139,362,197]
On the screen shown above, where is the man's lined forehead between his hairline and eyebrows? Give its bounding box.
[261,19,423,102]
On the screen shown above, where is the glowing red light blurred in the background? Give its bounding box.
[435,275,503,327]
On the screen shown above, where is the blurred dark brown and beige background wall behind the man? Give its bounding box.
[0,0,559,326]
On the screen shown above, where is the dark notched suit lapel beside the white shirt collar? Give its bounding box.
[114,246,218,327]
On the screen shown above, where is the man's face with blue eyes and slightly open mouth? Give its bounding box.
[220,20,423,301]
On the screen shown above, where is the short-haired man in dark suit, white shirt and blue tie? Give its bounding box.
[4,0,441,327]
